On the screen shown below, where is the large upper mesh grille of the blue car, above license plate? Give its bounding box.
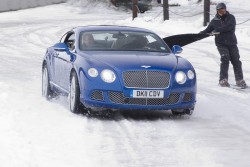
[123,70,170,88]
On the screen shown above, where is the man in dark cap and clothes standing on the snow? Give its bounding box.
[200,3,247,89]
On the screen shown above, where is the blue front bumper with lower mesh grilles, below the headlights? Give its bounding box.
[80,90,196,110]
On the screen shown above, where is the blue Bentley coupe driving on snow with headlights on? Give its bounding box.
[42,25,196,114]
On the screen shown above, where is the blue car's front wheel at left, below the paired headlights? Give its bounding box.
[69,72,81,113]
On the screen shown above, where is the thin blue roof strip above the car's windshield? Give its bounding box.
[73,25,153,33]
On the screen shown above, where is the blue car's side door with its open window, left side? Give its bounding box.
[55,32,75,93]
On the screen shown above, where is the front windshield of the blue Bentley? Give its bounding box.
[79,31,171,53]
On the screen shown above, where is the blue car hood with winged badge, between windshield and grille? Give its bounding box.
[80,51,177,71]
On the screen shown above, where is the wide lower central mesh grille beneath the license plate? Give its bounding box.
[109,92,180,105]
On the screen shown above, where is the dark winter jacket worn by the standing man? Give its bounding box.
[200,11,237,46]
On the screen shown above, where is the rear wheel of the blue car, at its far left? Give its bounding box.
[42,64,52,100]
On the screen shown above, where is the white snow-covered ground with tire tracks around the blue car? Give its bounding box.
[0,0,250,167]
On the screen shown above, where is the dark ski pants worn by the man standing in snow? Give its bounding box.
[217,45,243,81]
